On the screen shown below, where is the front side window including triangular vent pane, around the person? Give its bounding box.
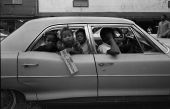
[91,25,161,54]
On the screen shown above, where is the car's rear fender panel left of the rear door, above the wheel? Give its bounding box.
[1,52,37,100]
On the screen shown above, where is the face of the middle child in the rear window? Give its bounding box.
[62,30,74,44]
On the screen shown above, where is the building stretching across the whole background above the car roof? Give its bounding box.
[0,0,170,32]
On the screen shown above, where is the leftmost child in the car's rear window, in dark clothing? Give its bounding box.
[35,32,59,52]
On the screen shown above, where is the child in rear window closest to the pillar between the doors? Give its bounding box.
[76,29,89,54]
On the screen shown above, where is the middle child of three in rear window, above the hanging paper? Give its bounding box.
[60,27,83,54]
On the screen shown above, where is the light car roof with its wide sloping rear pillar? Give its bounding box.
[1,16,134,51]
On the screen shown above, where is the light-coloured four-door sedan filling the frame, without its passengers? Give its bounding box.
[1,17,170,107]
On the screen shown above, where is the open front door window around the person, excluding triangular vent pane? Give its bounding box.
[91,26,143,53]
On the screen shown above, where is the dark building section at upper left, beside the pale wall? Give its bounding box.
[0,0,38,34]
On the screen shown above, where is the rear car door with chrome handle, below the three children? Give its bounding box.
[18,24,97,100]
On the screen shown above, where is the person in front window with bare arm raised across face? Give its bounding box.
[98,28,120,55]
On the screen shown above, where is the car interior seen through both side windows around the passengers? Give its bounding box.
[31,26,159,54]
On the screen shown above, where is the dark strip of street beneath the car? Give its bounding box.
[15,103,170,109]
